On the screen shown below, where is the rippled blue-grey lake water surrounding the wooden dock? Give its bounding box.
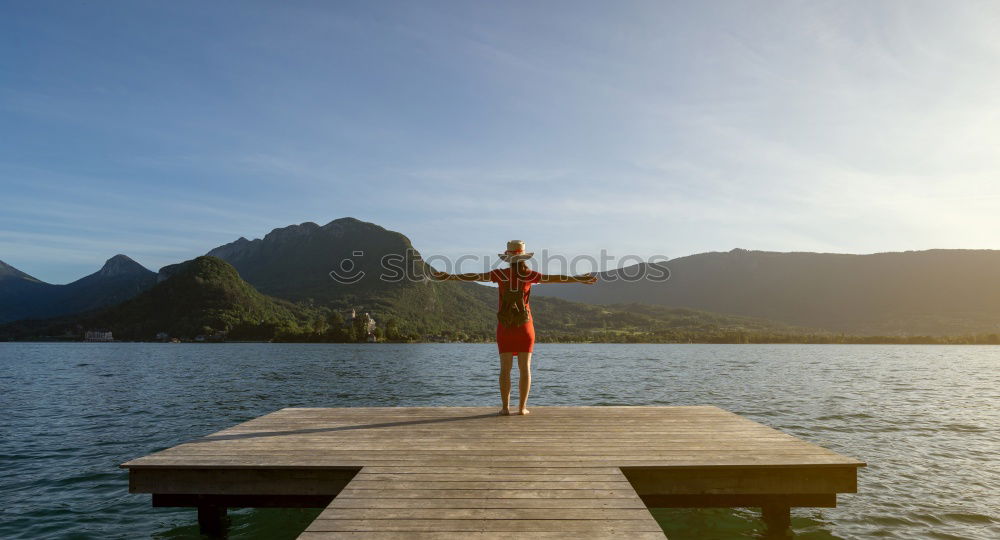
[0,343,1000,540]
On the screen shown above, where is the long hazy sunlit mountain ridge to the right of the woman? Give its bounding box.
[538,249,1000,336]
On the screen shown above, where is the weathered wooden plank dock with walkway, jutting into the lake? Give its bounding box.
[122,406,864,540]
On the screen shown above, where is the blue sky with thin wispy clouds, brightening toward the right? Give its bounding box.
[0,1,1000,283]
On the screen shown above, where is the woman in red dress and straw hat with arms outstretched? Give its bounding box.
[432,240,597,416]
